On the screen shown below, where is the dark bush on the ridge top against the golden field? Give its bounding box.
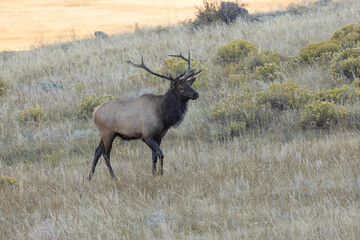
[192,0,248,26]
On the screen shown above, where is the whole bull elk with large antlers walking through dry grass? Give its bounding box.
[88,53,201,180]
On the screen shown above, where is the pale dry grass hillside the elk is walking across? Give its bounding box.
[0,0,360,239]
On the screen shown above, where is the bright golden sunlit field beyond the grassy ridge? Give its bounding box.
[0,0,304,51]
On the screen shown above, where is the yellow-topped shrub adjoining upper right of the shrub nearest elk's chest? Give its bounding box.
[256,81,313,110]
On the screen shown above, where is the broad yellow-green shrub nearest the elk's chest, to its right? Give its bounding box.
[211,90,270,127]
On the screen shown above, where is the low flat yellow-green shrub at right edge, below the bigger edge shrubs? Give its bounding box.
[318,85,360,104]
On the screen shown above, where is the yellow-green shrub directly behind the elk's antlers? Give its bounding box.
[161,57,209,88]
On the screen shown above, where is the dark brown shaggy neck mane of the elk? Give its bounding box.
[159,90,187,129]
